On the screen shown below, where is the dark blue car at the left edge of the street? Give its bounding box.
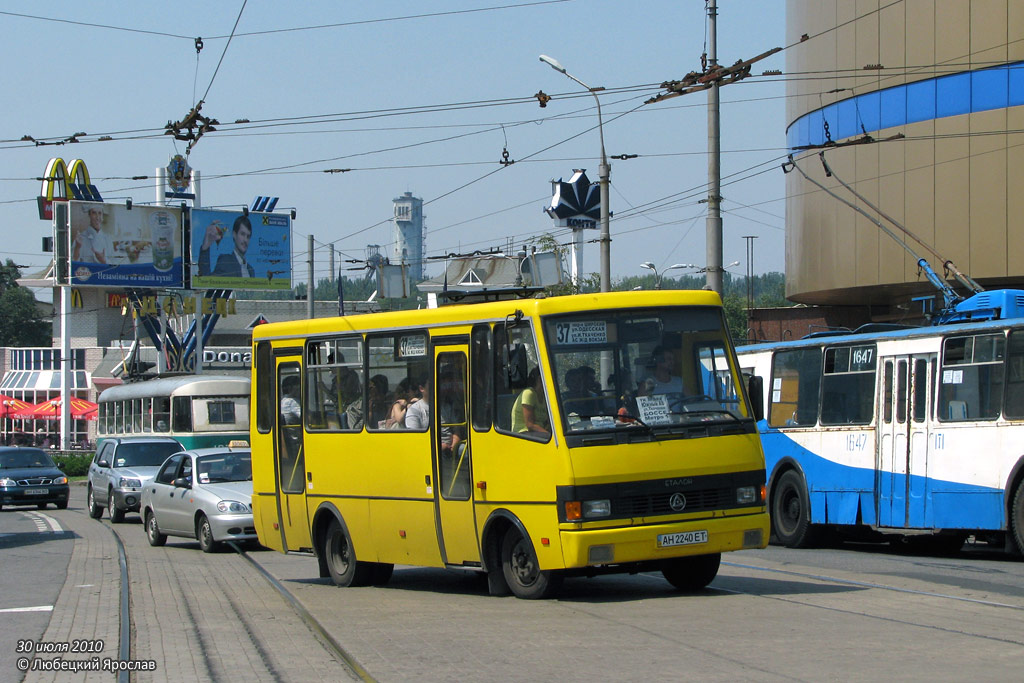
[0,447,71,510]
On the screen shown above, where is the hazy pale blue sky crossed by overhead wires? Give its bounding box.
[0,0,785,295]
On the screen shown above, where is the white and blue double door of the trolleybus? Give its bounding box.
[876,354,935,528]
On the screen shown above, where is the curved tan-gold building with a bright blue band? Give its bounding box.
[785,0,1024,307]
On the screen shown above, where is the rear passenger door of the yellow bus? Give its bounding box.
[273,360,312,551]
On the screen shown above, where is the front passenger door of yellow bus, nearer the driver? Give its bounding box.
[432,346,480,564]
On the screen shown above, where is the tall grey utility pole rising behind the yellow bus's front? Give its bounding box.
[707,0,724,296]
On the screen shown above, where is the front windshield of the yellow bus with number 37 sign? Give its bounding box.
[545,307,751,432]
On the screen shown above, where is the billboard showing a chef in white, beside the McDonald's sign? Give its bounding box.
[68,201,184,289]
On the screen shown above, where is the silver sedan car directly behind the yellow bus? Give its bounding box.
[140,442,256,553]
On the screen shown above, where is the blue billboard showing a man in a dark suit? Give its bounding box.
[191,209,292,290]
